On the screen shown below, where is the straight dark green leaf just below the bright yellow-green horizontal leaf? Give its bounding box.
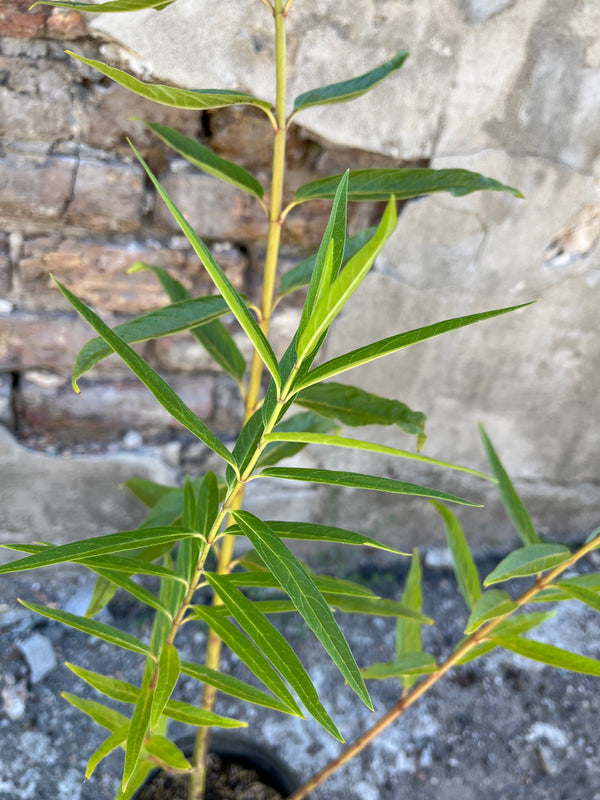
[257,467,481,508]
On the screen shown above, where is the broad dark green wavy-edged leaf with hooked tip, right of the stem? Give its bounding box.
[294,382,425,438]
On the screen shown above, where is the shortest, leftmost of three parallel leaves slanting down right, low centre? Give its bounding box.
[193,606,303,717]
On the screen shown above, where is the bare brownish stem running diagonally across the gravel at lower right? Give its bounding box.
[287,540,598,800]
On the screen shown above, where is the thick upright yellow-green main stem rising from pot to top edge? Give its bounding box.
[189,0,287,800]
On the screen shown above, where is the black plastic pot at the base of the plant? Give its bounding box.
[133,731,300,800]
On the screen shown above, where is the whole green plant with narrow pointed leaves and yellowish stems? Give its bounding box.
[0,0,600,800]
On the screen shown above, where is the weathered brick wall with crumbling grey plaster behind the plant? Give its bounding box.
[0,0,600,545]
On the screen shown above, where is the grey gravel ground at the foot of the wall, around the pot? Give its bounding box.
[0,554,600,800]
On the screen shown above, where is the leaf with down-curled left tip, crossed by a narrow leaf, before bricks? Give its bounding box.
[72,296,229,385]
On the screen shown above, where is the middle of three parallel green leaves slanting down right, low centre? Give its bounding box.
[206,573,342,741]
